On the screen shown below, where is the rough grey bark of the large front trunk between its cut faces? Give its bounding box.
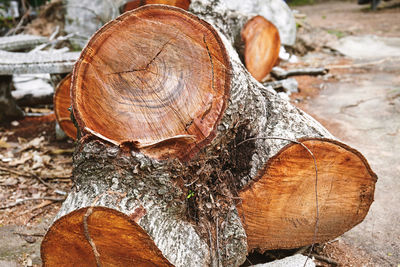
[53,0,332,266]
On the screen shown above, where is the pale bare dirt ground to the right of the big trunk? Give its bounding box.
[295,1,400,266]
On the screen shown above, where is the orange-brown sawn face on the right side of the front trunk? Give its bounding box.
[238,140,377,251]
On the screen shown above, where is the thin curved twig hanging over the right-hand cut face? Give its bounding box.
[237,136,319,267]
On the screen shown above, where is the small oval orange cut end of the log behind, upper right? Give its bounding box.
[241,16,281,81]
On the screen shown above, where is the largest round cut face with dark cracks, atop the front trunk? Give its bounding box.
[71,5,230,159]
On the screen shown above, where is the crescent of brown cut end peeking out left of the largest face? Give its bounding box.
[53,74,77,139]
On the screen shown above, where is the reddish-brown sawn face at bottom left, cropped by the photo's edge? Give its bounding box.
[41,207,172,267]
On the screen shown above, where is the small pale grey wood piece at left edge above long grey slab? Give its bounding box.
[0,34,48,51]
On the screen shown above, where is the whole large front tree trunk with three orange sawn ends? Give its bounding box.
[42,1,376,266]
